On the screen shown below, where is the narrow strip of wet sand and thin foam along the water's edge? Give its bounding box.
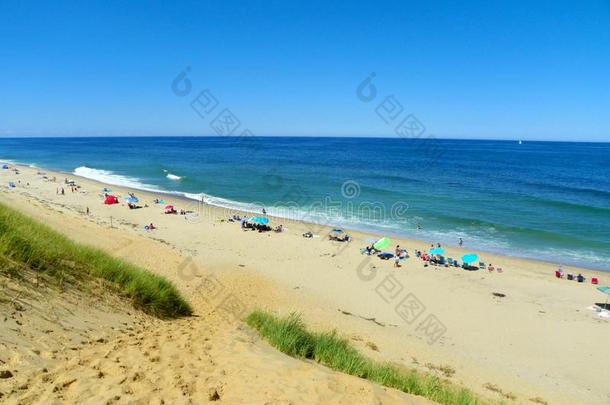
[4,160,610,279]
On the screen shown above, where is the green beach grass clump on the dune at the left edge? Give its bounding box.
[0,200,192,318]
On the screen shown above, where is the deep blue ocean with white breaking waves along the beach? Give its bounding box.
[0,137,610,270]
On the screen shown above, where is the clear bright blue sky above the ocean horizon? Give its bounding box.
[0,0,610,141]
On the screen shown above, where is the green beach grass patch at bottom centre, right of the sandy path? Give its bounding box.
[246,310,488,405]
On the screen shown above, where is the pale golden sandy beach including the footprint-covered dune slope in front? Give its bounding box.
[0,166,610,404]
